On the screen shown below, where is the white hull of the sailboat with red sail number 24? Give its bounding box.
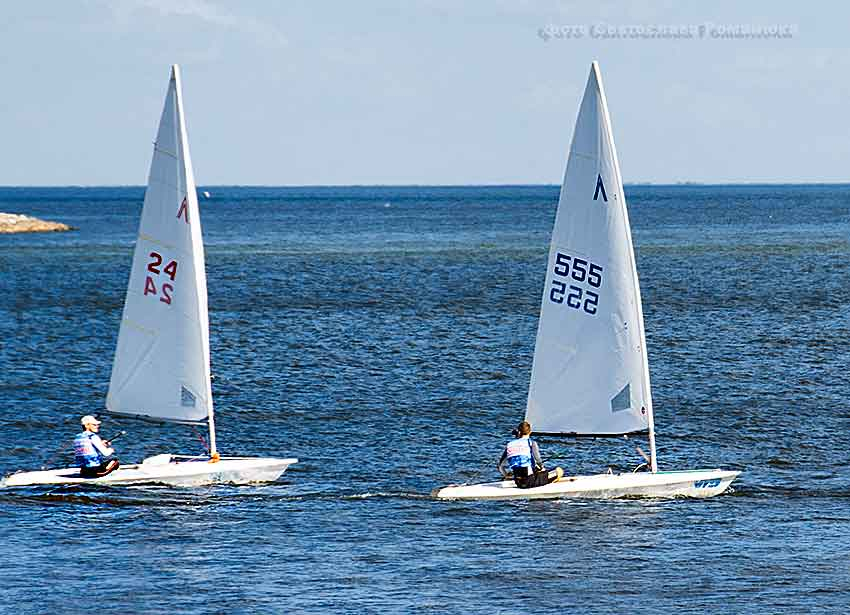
[3,455,298,487]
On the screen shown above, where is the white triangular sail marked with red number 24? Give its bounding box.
[106,65,212,422]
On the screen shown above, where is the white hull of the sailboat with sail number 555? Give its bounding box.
[433,469,740,500]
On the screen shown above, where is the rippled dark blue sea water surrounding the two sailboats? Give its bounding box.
[0,186,850,614]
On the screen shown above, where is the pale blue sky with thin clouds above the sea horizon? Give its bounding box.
[0,0,850,186]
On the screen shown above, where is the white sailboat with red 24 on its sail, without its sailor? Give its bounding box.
[5,65,298,487]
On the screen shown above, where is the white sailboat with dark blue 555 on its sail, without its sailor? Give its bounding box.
[434,62,740,499]
